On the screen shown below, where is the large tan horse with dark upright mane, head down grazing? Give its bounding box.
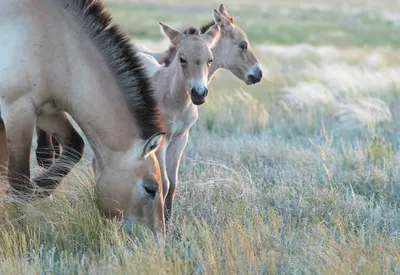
[0,0,165,236]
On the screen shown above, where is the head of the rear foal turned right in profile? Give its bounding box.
[209,4,262,85]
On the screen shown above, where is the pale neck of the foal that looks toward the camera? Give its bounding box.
[153,57,192,111]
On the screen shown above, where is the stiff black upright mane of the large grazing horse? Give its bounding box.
[69,0,165,139]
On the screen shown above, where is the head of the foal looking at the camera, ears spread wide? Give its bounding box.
[160,22,220,105]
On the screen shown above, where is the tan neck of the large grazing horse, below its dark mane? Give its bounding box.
[55,17,139,162]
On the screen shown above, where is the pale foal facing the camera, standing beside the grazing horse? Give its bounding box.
[141,23,220,224]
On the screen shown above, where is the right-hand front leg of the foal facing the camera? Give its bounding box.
[164,132,189,229]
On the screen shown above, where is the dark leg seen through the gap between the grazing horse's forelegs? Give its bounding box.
[36,126,54,169]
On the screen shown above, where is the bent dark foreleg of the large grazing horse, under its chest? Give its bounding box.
[34,112,85,195]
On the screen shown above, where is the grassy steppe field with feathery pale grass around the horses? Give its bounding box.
[0,0,400,274]
